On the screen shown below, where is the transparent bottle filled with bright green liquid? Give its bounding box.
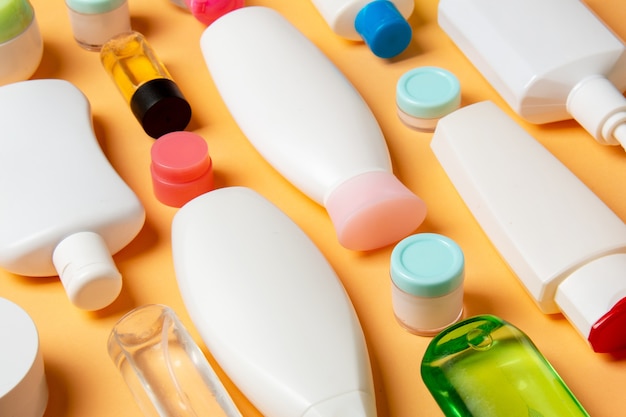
[421,315,589,417]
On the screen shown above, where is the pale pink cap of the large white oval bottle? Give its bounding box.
[325,171,426,250]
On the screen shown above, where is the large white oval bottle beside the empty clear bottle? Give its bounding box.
[172,187,376,417]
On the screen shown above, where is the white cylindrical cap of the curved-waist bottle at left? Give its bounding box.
[52,232,122,310]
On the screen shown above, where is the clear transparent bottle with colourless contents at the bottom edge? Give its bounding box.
[108,304,241,417]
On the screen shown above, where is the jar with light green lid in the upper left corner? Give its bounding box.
[0,0,43,85]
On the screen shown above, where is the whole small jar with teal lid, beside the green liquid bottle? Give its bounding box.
[391,233,465,336]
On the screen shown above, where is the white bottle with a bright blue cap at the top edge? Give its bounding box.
[312,0,415,58]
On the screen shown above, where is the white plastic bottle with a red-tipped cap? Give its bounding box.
[431,101,626,352]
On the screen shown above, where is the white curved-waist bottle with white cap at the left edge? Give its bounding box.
[0,80,145,310]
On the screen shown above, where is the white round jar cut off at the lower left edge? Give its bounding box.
[0,298,48,417]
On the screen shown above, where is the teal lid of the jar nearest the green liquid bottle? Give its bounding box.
[391,233,465,297]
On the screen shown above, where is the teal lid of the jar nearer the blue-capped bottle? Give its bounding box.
[396,67,461,119]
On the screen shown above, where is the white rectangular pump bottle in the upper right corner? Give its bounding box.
[438,0,626,147]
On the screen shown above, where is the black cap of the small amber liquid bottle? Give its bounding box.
[130,78,191,139]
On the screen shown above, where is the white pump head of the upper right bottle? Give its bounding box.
[567,75,626,149]
